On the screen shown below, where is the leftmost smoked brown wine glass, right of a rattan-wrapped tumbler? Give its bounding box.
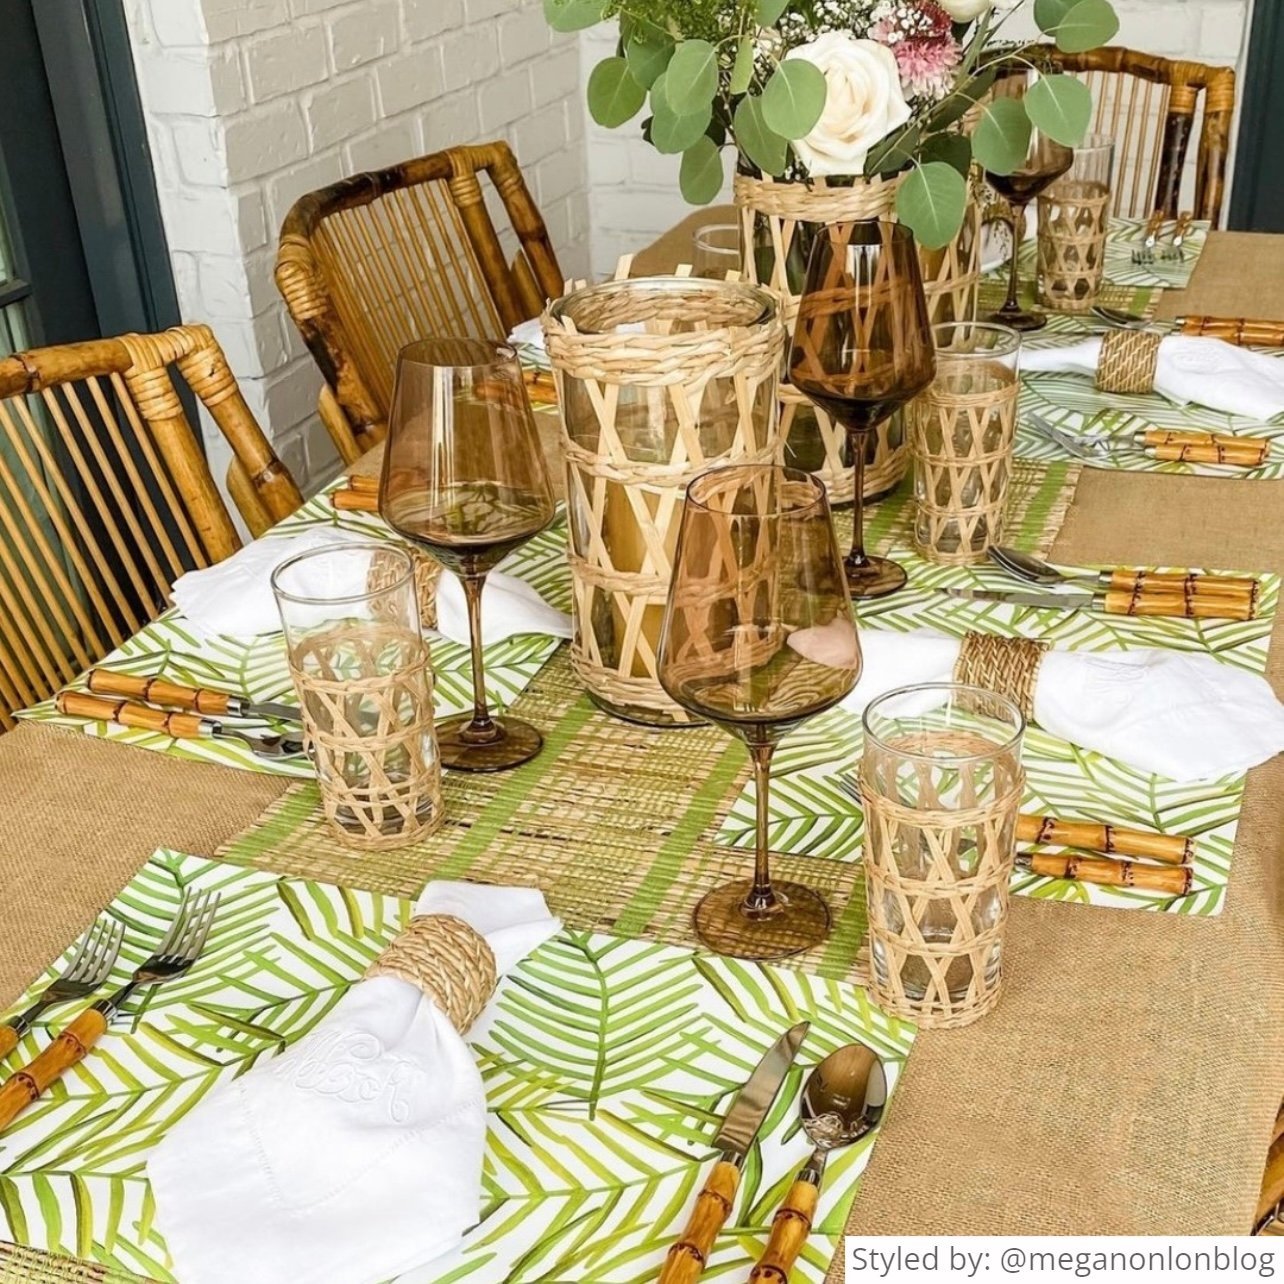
[379,339,553,772]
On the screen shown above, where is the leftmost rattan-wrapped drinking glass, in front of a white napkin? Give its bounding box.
[272,543,442,851]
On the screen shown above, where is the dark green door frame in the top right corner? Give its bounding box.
[1229,0,1284,232]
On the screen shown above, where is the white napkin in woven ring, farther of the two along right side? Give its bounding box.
[1021,334,1284,421]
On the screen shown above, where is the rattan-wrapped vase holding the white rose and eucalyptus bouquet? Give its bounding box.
[736,173,981,503]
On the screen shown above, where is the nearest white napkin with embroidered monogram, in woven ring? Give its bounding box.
[148,882,561,1284]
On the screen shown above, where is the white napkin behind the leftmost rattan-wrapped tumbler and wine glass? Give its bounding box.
[171,526,571,645]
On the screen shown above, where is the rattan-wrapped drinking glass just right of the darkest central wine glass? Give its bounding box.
[905,322,1021,566]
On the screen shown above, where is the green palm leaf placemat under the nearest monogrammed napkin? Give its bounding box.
[0,851,914,1284]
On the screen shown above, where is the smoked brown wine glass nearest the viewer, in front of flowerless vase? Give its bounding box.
[659,465,860,959]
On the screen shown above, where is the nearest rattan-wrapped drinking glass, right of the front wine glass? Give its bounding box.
[860,683,1025,1028]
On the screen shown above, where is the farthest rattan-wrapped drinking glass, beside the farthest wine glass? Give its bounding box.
[1039,134,1115,312]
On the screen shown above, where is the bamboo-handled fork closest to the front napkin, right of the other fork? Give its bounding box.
[0,892,218,1130]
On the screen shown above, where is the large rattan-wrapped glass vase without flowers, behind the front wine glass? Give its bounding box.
[544,276,786,727]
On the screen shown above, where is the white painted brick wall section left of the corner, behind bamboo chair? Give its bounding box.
[126,0,589,488]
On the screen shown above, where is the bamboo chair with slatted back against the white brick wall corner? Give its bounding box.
[276,143,562,464]
